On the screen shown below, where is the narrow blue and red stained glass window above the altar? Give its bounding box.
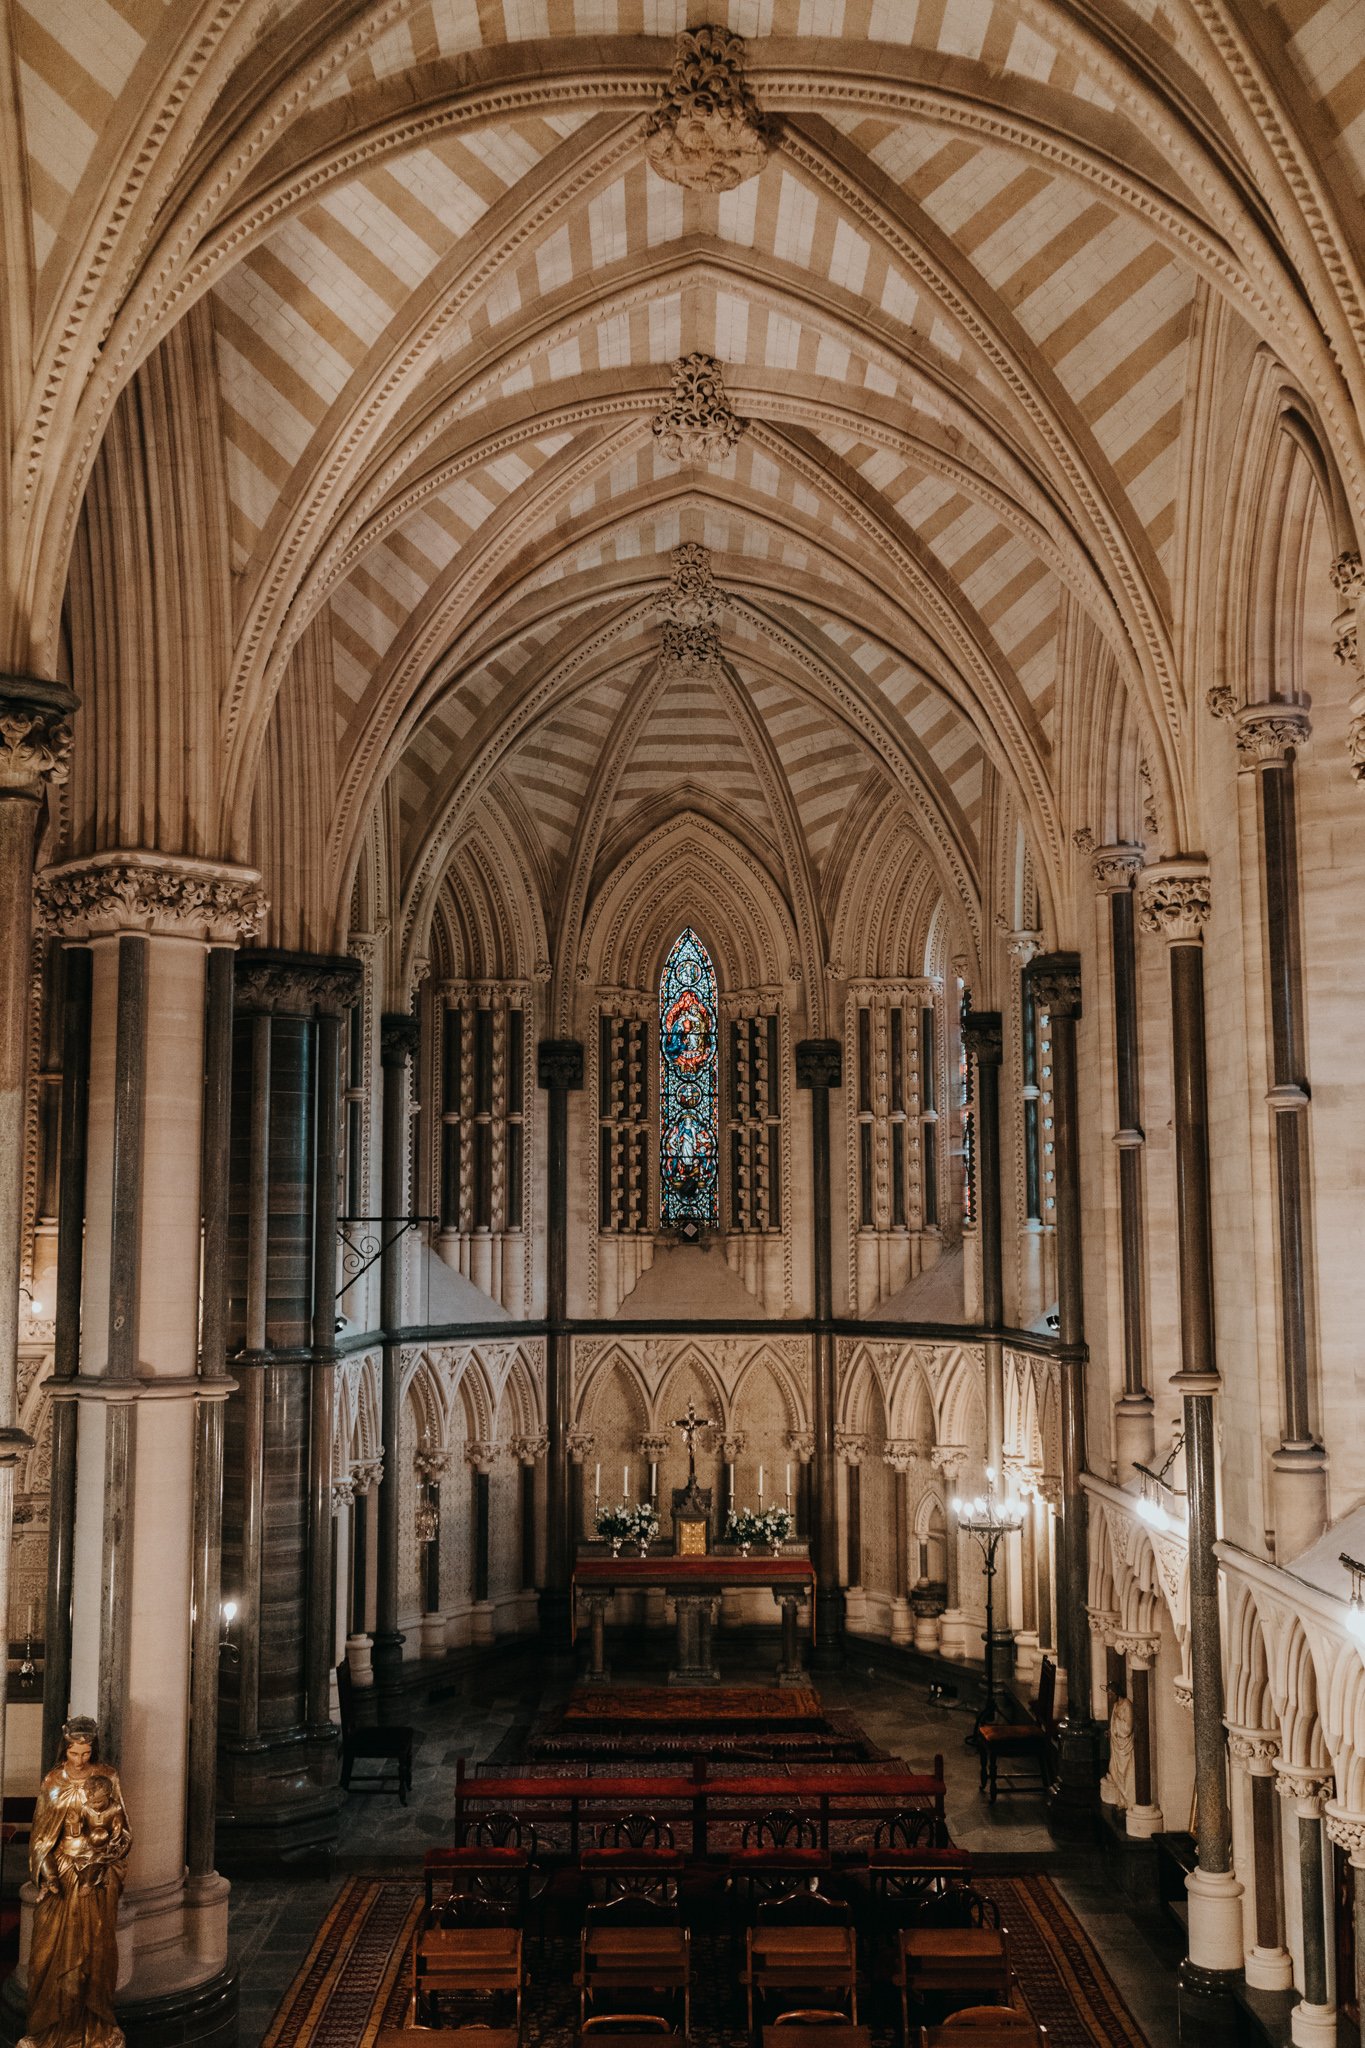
[659,926,720,1237]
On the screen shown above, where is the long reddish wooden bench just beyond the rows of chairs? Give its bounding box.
[454,1755,948,1862]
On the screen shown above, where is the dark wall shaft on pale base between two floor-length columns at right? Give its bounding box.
[1093,846,1154,1483]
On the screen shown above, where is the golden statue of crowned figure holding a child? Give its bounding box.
[18,1716,133,2048]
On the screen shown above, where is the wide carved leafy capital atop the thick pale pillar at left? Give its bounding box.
[35,852,270,942]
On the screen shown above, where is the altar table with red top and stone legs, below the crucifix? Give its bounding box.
[573,1544,814,1686]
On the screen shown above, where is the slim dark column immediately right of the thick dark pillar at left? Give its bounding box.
[370,1012,422,1710]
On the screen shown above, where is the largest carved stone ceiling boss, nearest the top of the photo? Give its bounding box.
[645,27,767,193]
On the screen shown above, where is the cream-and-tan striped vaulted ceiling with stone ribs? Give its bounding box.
[10,0,1365,983]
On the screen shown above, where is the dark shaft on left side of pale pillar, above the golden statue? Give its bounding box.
[43,946,90,1767]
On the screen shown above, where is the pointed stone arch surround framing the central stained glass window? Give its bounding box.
[573,809,806,1321]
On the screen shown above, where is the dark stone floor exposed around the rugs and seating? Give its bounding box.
[231,1653,1179,2048]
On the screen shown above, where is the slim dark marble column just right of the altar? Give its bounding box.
[796,1038,843,1671]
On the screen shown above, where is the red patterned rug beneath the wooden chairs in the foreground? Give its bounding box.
[262,1878,1146,2048]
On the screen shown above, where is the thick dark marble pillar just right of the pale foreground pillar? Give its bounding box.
[217,950,360,1868]
